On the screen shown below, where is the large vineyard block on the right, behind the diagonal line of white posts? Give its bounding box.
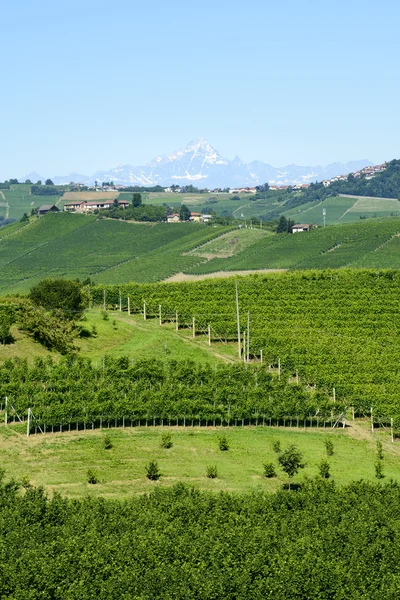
[91,269,400,426]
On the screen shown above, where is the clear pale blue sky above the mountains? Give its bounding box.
[0,0,400,180]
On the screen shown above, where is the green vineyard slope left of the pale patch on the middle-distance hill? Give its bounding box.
[0,213,229,293]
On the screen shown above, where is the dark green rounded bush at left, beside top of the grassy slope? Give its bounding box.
[29,279,85,321]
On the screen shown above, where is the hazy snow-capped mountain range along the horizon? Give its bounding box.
[21,138,372,188]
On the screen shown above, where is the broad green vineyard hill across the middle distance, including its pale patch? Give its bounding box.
[0,213,400,294]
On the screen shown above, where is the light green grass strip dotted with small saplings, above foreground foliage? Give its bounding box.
[0,422,400,498]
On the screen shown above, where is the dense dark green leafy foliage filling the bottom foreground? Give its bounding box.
[0,480,400,600]
